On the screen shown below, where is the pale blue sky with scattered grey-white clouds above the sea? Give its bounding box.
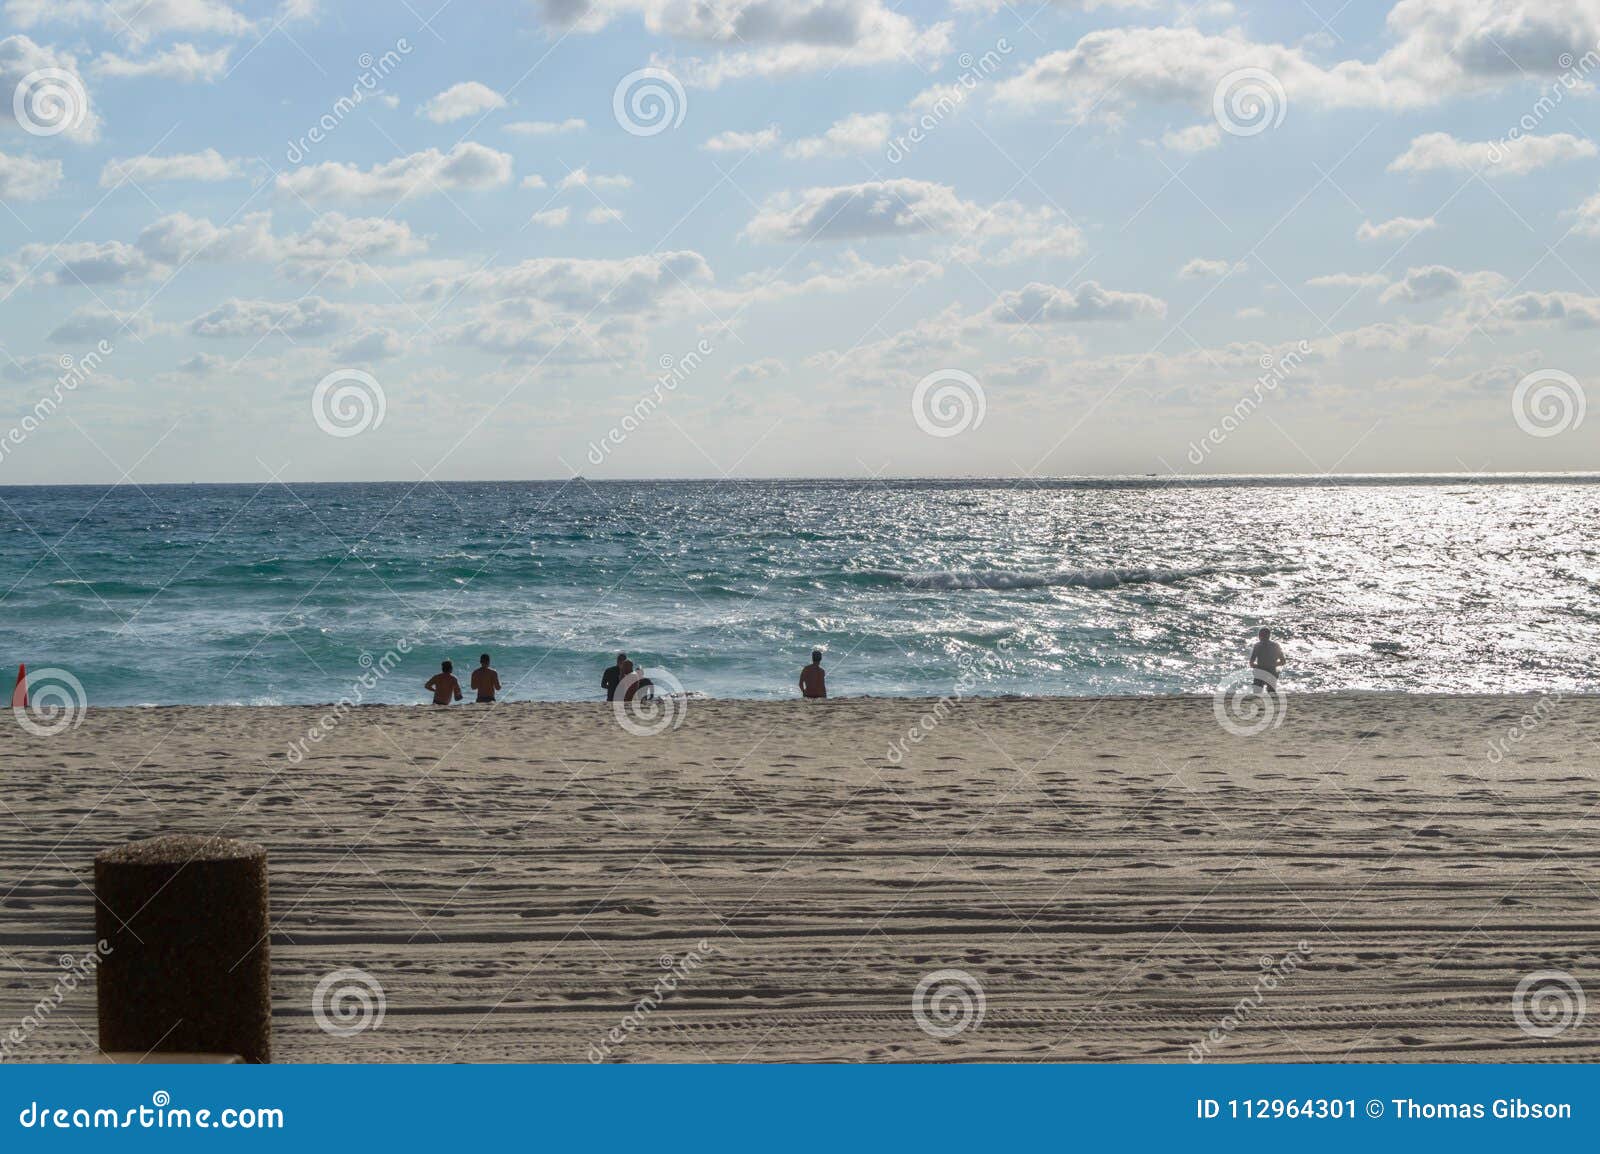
[0,0,1600,483]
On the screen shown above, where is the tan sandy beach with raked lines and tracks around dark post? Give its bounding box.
[0,695,1600,1063]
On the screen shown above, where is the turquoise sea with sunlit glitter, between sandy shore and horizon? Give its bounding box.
[0,479,1600,704]
